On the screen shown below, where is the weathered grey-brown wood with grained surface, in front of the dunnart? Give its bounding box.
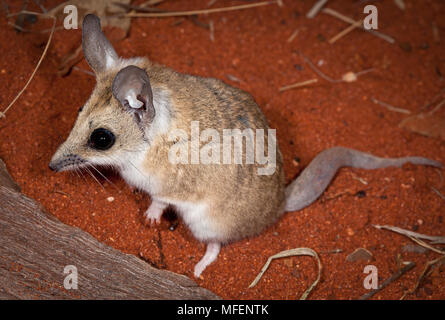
[0,160,218,299]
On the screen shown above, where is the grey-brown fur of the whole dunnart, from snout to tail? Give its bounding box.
[50,16,440,276]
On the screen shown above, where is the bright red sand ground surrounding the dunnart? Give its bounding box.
[0,0,445,299]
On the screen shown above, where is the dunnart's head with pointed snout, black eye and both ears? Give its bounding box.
[49,15,156,171]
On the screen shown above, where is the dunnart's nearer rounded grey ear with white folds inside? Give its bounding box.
[112,66,155,125]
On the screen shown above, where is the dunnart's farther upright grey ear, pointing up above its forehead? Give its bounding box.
[82,14,119,73]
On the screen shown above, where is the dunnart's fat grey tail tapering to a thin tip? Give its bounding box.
[285,147,442,211]
